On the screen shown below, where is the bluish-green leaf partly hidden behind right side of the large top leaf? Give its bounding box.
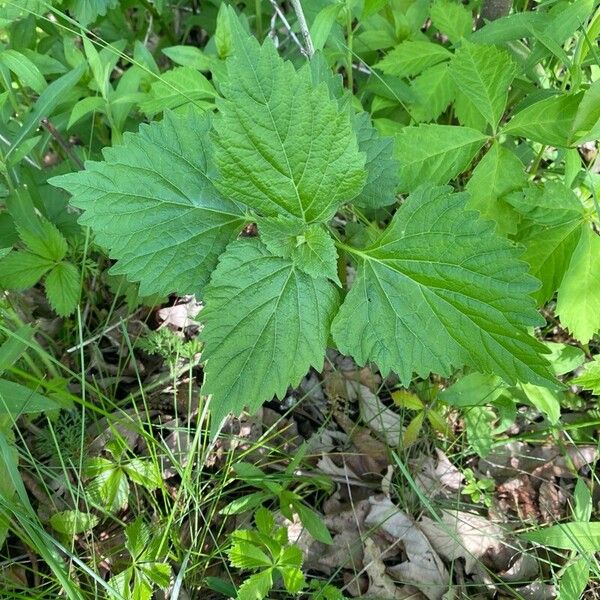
[353,112,400,208]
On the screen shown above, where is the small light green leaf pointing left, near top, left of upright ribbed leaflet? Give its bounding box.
[374,40,452,77]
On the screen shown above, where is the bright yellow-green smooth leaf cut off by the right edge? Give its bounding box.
[556,227,600,344]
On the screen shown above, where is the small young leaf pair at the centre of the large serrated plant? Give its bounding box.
[257,215,339,284]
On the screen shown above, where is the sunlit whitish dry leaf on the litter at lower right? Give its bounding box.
[419,510,515,575]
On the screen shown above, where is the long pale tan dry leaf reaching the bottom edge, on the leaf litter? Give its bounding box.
[365,498,450,600]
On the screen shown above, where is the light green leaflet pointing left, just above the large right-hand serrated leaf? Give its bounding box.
[395,124,487,192]
